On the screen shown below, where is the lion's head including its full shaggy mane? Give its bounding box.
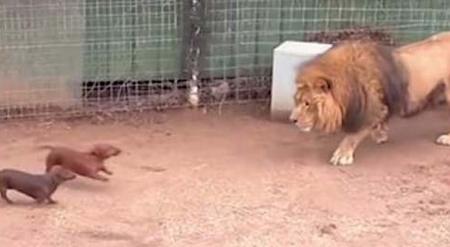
[290,41,401,133]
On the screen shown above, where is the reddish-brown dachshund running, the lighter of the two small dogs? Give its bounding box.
[39,144,122,182]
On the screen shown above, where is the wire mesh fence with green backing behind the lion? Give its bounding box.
[0,0,450,119]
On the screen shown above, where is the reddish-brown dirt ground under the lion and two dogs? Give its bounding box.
[0,106,450,247]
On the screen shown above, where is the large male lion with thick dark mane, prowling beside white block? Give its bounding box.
[290,33,450,165]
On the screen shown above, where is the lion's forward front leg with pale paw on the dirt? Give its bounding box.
[330,128,372,166]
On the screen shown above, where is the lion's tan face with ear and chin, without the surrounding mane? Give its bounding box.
[290,71,343,132]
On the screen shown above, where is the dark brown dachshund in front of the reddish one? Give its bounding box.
[0,166,76,204]
